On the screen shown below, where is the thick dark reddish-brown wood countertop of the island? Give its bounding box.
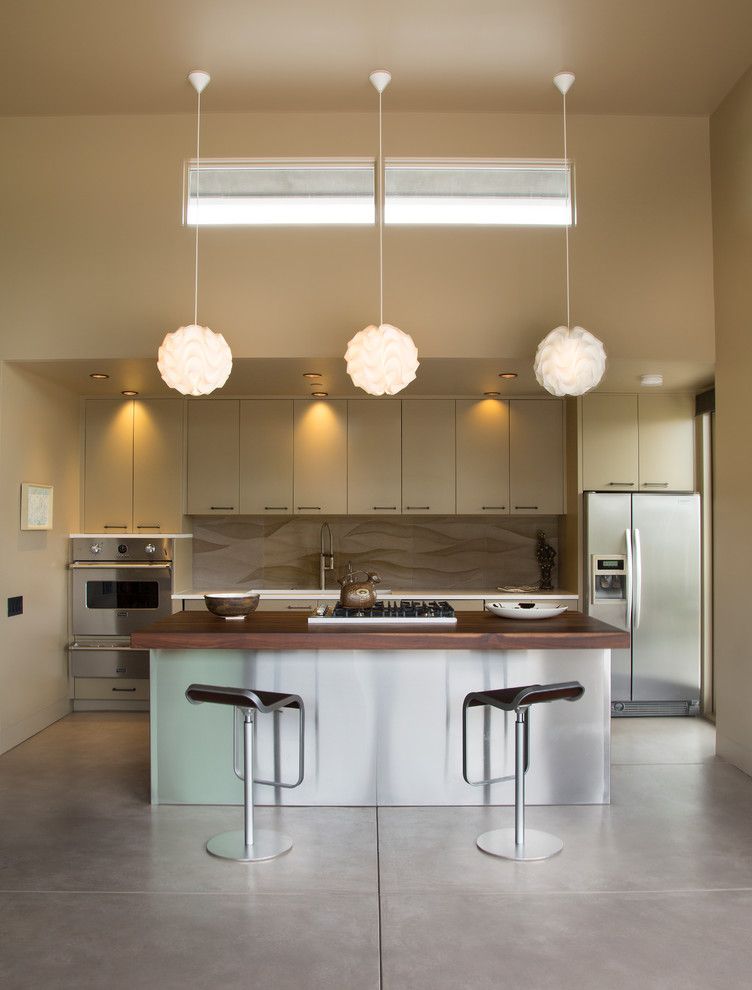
[131,611,629,651]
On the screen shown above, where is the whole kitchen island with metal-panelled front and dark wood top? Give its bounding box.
[131,611,629,805]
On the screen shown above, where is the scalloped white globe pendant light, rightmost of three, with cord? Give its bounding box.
[535,72,606,396]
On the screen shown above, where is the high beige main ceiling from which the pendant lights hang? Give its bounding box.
[0,0,752,114]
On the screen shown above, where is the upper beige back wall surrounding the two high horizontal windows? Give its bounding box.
[0,113,713,361]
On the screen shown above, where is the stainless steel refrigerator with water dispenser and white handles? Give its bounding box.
[585,492,701,715]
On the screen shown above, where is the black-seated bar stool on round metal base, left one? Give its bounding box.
[185,684,305,863]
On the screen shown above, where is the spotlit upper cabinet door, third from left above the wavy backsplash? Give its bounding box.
[293,399,347,515]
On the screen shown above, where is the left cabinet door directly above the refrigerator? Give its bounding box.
[582,394,638,492]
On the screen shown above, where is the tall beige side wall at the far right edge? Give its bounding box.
[710,71,752,773]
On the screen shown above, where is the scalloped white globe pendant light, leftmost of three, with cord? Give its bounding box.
[157,70,232,395]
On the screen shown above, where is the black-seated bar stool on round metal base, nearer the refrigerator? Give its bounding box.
[462,681,585,862]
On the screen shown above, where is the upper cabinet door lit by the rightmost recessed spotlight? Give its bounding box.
[457,399,509,515]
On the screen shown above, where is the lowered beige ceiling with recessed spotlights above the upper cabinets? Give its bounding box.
[13,357,713,398]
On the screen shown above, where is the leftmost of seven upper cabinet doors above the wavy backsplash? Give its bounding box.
[186,399,240,516]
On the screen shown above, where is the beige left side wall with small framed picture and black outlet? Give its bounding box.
[0,362,79,753]
